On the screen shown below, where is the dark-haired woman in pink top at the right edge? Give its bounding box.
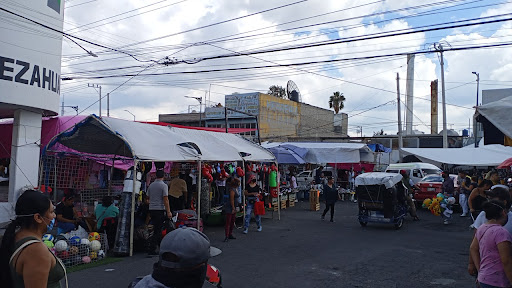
[469,200,512,288]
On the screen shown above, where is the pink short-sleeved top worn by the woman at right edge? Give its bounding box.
[476,224,512,287]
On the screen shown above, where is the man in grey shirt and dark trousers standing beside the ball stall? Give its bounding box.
[147,170,172,255]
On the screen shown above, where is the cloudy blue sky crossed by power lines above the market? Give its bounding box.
[25,0,512,136]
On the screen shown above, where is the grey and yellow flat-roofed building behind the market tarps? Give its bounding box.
[159,92,348,141]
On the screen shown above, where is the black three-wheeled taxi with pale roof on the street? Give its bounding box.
[355,172,408,229]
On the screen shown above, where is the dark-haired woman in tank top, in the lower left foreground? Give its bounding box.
[0,190,66,288]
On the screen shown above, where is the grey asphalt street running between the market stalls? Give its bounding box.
[69,202,474,288]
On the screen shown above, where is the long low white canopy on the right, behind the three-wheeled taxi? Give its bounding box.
[402,145,512,166]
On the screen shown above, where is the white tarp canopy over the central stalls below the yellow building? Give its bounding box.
[262,142,374,164]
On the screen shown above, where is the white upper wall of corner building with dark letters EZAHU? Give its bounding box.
[0,0,64,117]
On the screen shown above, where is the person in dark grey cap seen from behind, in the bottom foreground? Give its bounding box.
[135,227,220,288]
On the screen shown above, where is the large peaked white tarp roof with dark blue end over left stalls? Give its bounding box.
[48,115,272,162]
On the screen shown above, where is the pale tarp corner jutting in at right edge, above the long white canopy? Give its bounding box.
[476,96,512,138]
